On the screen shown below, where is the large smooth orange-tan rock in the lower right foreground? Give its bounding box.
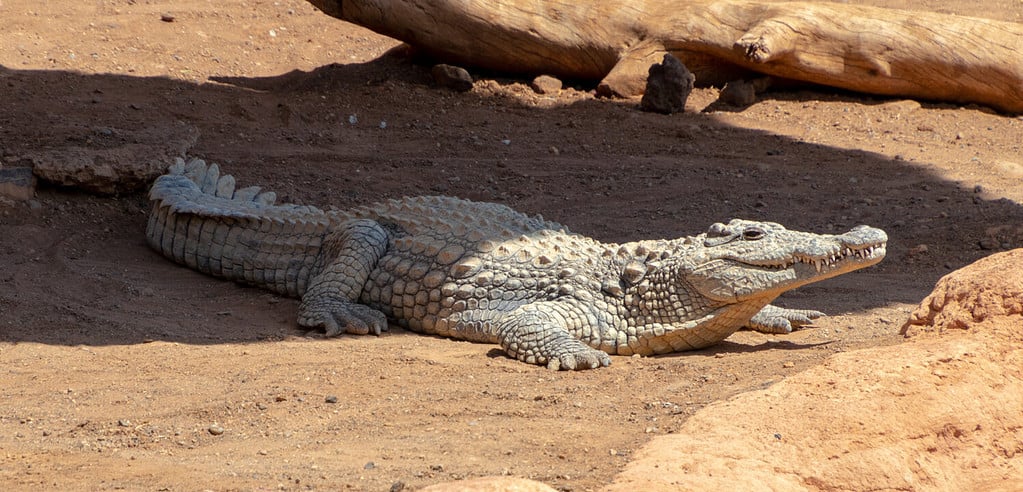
[607,250,1023,491]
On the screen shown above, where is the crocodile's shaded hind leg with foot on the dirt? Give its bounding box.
[299,220,388,337]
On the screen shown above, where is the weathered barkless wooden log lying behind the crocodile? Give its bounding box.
[309,0,1023,113]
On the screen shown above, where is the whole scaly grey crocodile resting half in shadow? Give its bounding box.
[146,159,888,370]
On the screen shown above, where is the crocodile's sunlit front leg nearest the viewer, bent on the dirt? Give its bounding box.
[497,301,611,370]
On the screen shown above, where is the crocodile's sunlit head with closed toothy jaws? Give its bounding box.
[684,219,888,304]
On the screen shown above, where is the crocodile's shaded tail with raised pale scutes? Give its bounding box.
[146,158,330,297]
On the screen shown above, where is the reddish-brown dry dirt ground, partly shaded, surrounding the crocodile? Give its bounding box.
[0,0,1023,491]
